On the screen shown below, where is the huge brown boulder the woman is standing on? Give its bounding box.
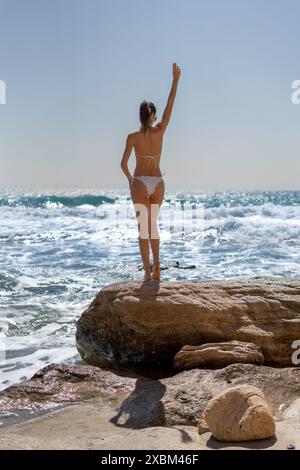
[76,277,300,370]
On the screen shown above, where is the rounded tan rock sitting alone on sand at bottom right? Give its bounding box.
[198,384,276,441]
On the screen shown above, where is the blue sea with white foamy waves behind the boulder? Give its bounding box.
[0,190,300,389]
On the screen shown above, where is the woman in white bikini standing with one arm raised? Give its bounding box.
[121,63,181,281]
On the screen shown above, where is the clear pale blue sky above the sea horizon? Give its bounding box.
[0,0,300,191]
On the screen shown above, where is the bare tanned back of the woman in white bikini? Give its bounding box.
[133,127,164,176]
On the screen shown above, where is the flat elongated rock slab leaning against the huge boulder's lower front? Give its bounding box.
[173,341,264,370]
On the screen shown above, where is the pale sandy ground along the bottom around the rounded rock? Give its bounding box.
[0,400,300,450]
